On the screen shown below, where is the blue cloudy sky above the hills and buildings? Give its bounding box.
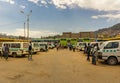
[0,0,120,37]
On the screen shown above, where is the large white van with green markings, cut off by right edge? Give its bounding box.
[98,40,120,65]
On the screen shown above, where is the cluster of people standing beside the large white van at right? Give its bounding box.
[84,43,99,65]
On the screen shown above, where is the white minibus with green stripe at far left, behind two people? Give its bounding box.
[0,42,29,57]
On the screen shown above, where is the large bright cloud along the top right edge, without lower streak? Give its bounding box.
[52,0,120,11]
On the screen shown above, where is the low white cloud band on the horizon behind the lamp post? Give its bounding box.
[2,29,59,38]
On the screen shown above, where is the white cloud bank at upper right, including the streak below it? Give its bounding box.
[51,0,120,21]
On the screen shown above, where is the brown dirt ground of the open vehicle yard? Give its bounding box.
[0,49,120,83]
